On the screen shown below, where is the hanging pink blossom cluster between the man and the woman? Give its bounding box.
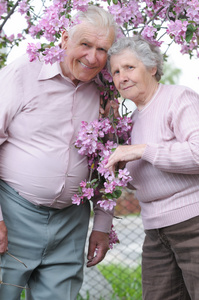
[72,116,132,210]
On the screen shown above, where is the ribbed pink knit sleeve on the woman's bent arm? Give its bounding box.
[142,89,199,174]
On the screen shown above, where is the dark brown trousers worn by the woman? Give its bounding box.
[142,217,199,300]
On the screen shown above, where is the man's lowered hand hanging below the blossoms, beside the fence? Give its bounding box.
[87,231,109,267]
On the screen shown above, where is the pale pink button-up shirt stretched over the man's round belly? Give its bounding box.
[0,56,112,232]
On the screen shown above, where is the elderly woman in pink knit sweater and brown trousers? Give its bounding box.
[106,36,199,300]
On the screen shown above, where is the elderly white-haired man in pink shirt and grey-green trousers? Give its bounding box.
[0,6,117,300]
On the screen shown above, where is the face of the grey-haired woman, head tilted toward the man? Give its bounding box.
[110,49,158,107]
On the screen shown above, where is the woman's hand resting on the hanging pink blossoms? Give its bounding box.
[105,144,146,172]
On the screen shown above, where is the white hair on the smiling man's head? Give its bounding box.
[68,5,119,39]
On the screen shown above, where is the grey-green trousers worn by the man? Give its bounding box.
[0,181,90,300]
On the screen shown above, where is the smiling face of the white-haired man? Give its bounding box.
[60,22,115,84]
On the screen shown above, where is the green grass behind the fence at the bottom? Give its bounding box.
[21,264,142,300]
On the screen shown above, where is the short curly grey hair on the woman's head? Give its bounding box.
[107,35,163,81]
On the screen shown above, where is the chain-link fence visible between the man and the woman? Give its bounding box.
[80,189,144,300]
